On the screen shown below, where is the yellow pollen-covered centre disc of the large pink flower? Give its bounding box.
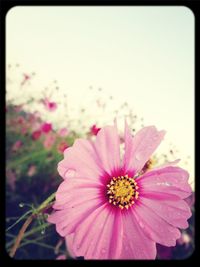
[107,175,139,209]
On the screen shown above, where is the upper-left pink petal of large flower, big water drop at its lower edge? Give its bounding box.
[58,139,103,180]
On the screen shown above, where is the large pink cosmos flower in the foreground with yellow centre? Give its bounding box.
[48,124,191,259]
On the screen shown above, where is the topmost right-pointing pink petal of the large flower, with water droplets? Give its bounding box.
[136,166,192,199]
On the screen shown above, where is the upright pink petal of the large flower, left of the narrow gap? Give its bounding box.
[94,124,120,176]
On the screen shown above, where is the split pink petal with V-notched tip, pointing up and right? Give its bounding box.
[124,123,165,174]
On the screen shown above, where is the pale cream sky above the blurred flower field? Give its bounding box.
[6,6,194,188]
